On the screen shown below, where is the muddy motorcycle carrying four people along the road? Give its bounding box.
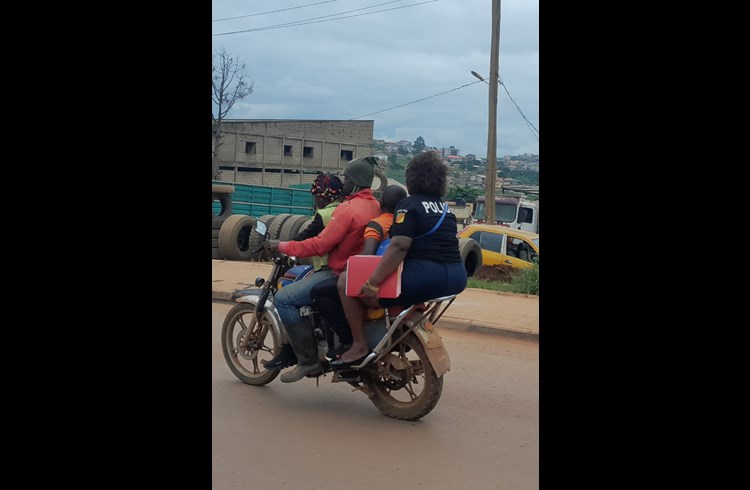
[221,221,457,420]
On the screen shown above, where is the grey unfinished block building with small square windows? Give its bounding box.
[215,119,374,187]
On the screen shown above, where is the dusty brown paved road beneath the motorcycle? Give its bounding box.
[212,302,539,490]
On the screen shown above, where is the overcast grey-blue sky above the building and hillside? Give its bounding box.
[211,0,539,158]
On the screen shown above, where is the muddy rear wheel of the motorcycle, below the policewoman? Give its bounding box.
[363,334,443,420]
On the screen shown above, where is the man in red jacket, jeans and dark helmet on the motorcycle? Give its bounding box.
[266,157,380,383]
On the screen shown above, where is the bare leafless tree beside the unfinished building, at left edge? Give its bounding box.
[211,48,255,179]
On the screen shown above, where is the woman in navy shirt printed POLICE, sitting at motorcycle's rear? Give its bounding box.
[330,151,466,369]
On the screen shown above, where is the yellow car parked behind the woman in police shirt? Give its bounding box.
[456,224,539,269]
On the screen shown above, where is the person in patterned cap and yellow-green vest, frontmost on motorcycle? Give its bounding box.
[263,173,346,371]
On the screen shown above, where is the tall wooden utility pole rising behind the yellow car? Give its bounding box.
[484,0,500,225]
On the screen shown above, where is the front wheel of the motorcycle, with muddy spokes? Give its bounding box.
[221,303,281,386]
